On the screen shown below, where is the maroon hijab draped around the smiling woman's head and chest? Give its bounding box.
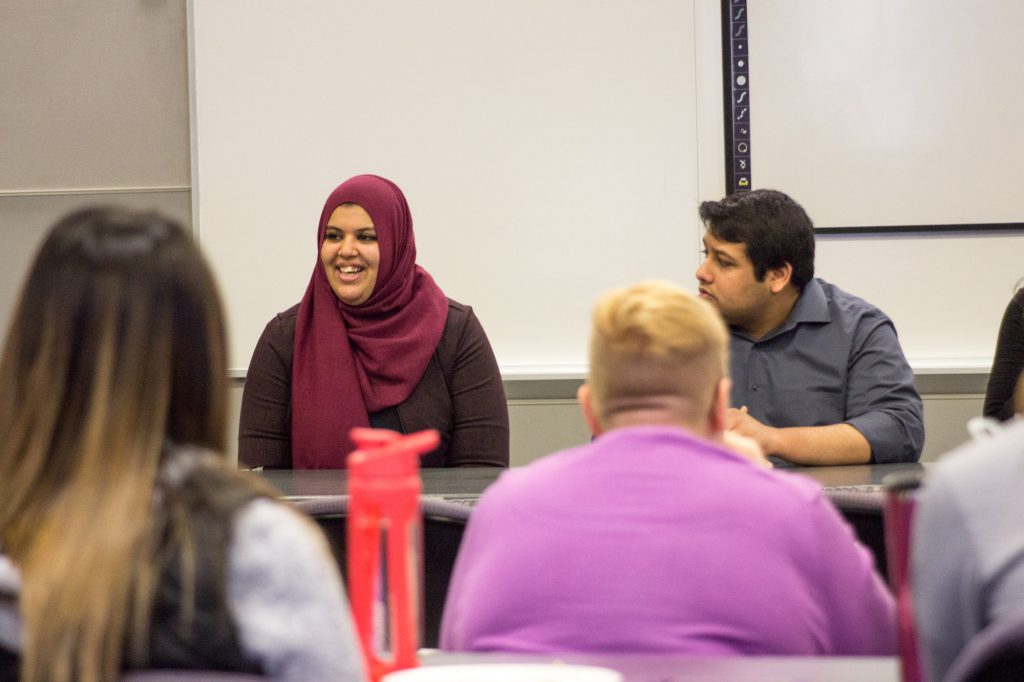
[292,175,447,469]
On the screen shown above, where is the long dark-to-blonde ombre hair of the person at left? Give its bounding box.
[0,209,232,682]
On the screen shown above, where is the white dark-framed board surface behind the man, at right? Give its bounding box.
[748,0,1024,229]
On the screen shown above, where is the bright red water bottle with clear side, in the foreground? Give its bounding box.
[348,428,440,682]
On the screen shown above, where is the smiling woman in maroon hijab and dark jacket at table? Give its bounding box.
[239,175,509,469]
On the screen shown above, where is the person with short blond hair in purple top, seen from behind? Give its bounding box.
[440,283,895,655]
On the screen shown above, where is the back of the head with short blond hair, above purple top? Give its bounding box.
[588,282,729,422]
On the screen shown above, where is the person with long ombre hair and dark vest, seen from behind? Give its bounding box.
[0,209,364,682]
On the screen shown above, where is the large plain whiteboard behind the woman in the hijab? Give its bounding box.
[189,0,724,372]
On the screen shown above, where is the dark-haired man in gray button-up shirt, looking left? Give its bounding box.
[696,189,925,464]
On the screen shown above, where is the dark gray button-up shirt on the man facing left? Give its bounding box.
[729,279,925,463]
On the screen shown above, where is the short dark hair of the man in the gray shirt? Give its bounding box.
[700,189,814,291]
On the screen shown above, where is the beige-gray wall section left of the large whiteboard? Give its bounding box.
[0,0,191,346]
